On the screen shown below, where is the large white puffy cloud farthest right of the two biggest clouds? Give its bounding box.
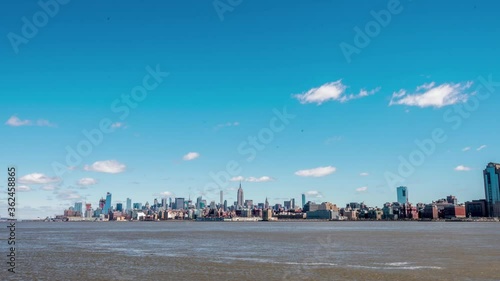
[389,82,474,108]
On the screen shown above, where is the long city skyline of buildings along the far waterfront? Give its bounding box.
[56,163,500,221]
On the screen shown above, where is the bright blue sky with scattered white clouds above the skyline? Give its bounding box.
[0,0,500,218]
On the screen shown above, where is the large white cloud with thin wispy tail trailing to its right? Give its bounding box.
[293,80,380,105]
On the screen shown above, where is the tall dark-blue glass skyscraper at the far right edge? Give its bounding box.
[483,163,500,217]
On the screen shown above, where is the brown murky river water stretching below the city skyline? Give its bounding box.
[0,222,500,281]
